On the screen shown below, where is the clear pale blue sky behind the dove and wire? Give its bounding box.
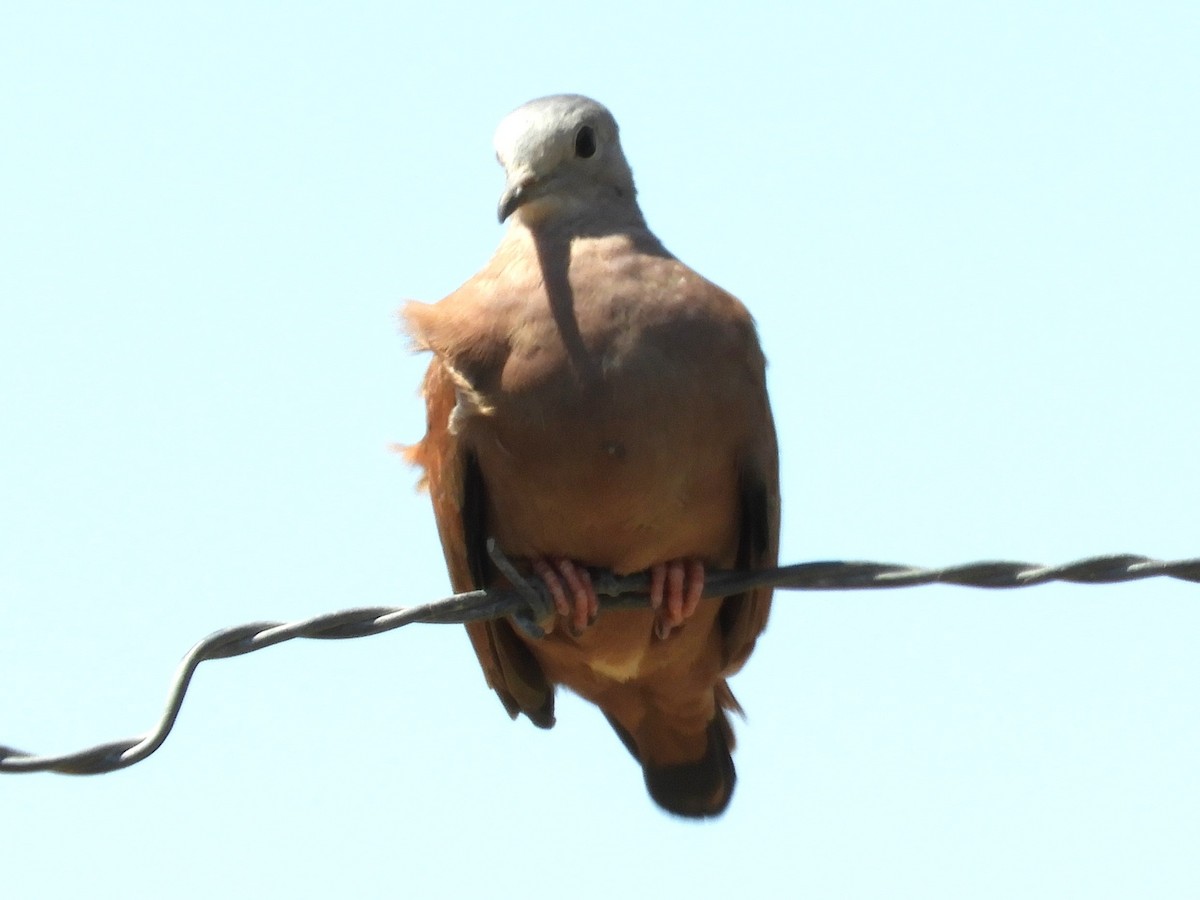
[0,0,1200,900]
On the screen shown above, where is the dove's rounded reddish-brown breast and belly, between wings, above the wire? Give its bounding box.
[454,235,764,571]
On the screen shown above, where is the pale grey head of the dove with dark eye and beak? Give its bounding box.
[494,94,636,223]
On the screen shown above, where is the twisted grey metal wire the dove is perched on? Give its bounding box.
[0,554,1200,775]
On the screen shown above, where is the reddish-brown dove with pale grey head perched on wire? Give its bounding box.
[401,94,780,818]
